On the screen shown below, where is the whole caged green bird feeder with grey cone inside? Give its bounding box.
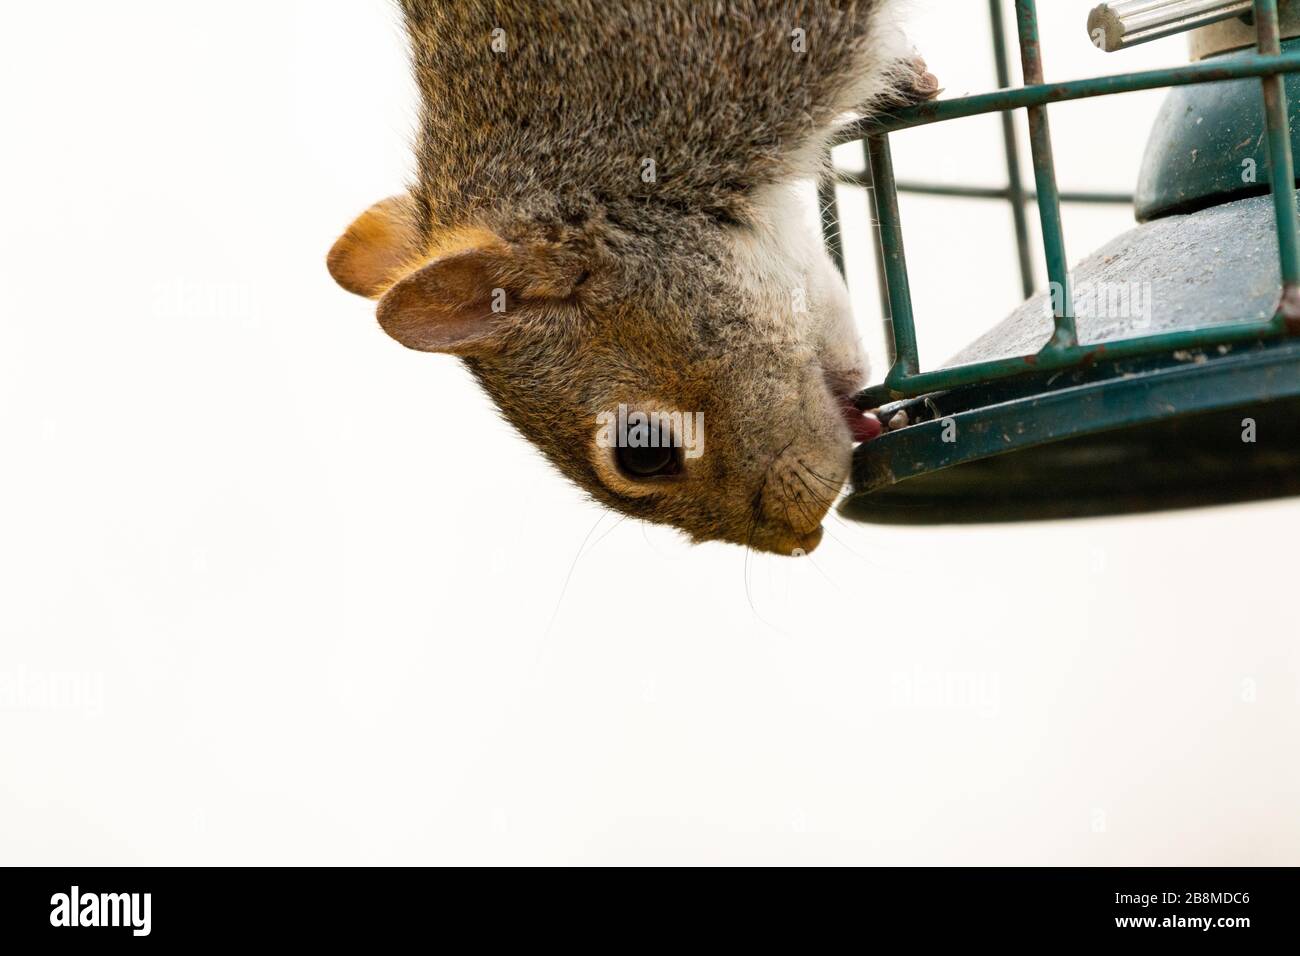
[822,0,1300,524]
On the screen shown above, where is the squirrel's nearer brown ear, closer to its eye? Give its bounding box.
[378,239,586,355]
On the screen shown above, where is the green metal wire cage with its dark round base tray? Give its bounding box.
[819,0,1300,522]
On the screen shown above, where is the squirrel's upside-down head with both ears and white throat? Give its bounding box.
[328,187,866,554]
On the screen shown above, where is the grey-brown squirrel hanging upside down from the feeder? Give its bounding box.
[326,0,936,554]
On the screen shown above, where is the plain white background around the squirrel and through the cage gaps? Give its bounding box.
[0,0,1300,865]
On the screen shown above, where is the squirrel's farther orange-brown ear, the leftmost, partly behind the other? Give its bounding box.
[325,194,423,299]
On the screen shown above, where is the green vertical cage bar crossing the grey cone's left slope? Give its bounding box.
[1015,0,1079,349]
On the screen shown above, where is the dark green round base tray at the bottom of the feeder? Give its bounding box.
[840,339,1300,524]
